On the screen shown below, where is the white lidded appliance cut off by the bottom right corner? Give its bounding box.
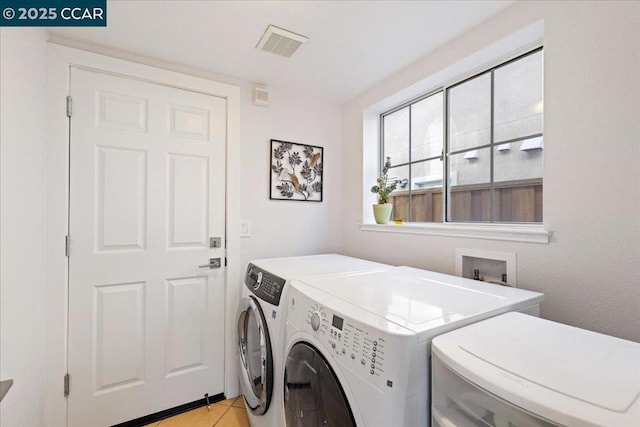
[432,313,640,427]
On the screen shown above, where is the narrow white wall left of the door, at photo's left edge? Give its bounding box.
[0,28,46,427]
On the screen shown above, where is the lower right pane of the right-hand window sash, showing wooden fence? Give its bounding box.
[493,138,543,222]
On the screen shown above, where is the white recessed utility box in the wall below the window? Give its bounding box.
[456,248,517,287]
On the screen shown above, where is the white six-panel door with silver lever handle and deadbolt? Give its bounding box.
[68,67,226,426]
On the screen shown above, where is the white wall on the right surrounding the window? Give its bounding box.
[342,2,640,341]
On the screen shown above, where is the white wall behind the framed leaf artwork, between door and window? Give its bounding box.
[241,85,345,265]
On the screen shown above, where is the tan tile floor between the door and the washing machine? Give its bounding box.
[146,396,249,427]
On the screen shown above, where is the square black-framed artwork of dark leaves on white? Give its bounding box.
[269,139,323,202]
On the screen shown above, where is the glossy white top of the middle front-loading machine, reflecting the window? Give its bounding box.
[300,268,544,341]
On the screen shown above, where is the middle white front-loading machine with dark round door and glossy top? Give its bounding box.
[284,268,544,427]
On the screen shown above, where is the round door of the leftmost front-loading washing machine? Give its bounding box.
[238,296,273,415]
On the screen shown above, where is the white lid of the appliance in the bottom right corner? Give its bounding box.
[433,313,640,420]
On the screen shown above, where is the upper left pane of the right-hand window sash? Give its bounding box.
[447,73,491,152]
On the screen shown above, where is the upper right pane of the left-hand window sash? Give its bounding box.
[411,92,443,162]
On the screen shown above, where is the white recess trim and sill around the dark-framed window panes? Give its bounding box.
[360,21,553,244]
